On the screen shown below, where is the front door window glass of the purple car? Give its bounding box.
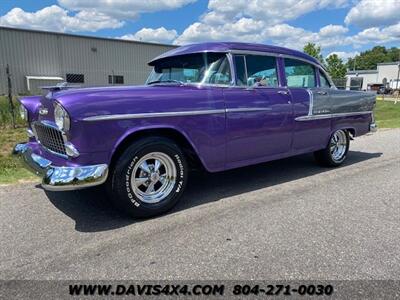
[235,55,278,87]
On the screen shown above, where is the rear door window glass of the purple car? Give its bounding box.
[285,58,316,88]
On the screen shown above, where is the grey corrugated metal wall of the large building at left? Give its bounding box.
[0,27,174,94]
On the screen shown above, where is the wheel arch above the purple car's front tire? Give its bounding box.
[109,126,207,169]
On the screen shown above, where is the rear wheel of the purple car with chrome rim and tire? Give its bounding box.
[314,129,350,167]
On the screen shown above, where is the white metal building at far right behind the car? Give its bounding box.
[346,61,400,90]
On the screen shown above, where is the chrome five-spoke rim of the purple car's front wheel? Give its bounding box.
[131,152,177,204]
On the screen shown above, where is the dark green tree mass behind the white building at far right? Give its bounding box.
[347,46,400,70]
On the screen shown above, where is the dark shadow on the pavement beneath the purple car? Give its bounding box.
[46,151,382,232]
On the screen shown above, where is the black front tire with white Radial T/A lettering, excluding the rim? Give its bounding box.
[113,139,188,217]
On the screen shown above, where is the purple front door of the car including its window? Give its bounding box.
[224,55,293,168]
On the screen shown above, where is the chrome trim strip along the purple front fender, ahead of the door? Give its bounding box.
[83,109,225,122]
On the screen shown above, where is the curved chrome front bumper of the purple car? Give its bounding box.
[13,144,108,191]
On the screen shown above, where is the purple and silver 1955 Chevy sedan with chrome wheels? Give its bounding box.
[14,43,376,217]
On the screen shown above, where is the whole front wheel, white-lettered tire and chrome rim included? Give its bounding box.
[109,137,188,218]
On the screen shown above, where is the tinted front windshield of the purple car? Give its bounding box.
[146,53,231,84]
